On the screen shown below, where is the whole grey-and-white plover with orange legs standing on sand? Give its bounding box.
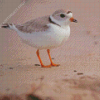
[1,10,77,68]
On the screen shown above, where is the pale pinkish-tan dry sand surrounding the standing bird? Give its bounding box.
[0,0,100,100]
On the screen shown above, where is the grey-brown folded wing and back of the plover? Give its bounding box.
[16,16,50,33]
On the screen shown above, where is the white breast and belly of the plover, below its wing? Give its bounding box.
[17,24,70,49]
